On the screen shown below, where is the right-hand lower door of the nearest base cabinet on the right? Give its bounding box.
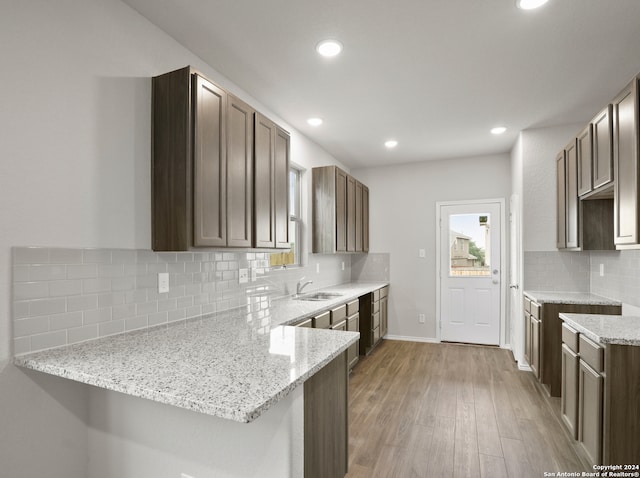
[578,360,603,465]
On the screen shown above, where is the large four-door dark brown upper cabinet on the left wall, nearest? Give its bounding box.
[152,67,289,251]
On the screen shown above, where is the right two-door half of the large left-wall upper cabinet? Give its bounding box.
[254,113,289,248]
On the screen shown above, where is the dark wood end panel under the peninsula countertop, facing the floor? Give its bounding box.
[304,352,349,478]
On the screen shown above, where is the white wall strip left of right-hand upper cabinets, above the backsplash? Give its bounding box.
[516,123,584,251]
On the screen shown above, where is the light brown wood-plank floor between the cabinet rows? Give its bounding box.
[346,340,592,478]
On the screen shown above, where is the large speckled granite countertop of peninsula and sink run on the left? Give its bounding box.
[14,282,388,423]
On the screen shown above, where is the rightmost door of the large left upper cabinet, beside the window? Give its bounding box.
[273,127,290,249]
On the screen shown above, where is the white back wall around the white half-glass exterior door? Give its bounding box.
[352,154,511,340]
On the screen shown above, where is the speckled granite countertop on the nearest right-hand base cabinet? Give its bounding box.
[560,313,640,346]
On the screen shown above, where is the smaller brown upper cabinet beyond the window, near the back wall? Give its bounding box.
[311,166,369,254]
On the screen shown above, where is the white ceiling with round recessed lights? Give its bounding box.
[124,0,640,167]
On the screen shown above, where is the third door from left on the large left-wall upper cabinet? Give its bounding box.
[253,113,276,248]
